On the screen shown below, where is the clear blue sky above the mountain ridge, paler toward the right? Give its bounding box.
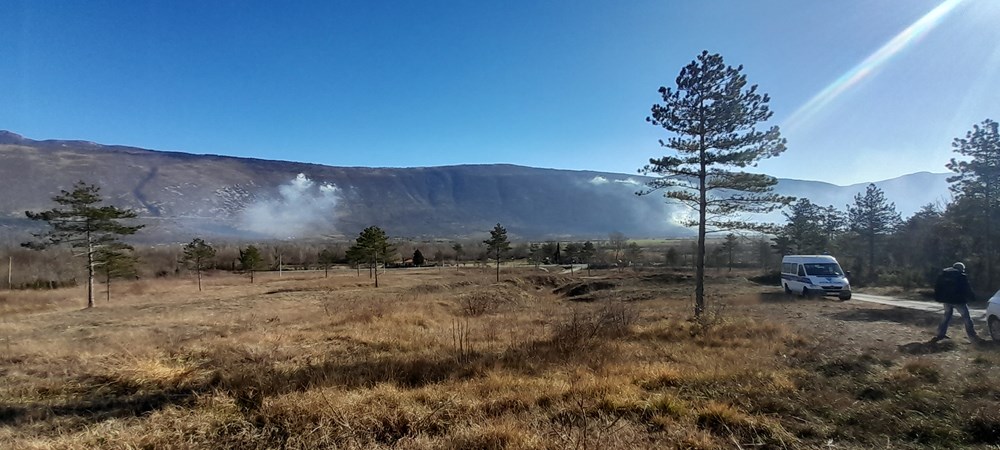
[0,0,1000,184]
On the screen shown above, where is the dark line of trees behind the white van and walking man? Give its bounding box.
[773,119,1000,296]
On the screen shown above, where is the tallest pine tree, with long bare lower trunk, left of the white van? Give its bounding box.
[638,51,791,316]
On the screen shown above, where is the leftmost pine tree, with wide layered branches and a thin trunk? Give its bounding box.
[21,181,144,308]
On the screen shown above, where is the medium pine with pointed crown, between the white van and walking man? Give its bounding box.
[847,183,902,280]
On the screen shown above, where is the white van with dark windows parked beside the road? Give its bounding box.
[781,255,851,300]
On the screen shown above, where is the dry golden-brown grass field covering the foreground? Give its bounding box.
[0,268,1000,449]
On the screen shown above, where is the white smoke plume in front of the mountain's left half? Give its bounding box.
[240,173,340,239]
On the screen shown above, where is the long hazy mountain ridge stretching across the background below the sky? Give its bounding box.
[0,131,948,242]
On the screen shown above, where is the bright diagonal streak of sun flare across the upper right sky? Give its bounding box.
[782,0,965,132]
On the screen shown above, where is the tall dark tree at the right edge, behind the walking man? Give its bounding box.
[946,119,1000,289]
